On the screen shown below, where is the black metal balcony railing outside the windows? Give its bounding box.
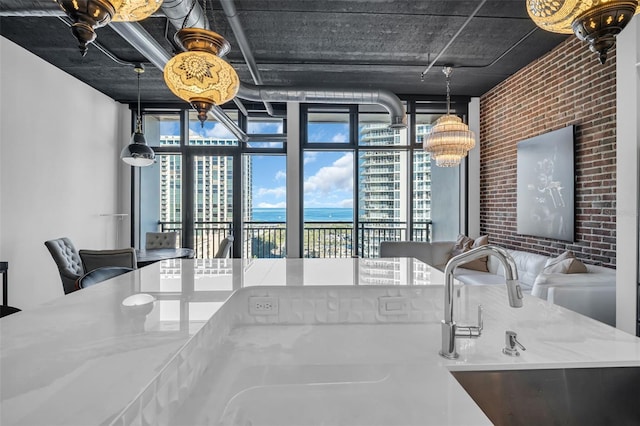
[159,221,432,259]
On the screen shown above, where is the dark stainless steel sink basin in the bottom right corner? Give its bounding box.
[452,367,640,426]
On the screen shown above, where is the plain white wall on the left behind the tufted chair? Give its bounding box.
[0,37,130,309]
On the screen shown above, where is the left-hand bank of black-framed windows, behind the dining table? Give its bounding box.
[133,108,286,258]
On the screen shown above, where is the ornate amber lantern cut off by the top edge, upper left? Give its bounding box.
[55,0,162,56]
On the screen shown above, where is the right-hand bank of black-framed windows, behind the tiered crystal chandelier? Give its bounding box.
[302,102,462,257]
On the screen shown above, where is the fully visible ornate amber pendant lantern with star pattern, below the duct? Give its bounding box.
[164,28,240,126]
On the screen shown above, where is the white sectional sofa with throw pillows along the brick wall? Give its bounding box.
[380,241,616,326]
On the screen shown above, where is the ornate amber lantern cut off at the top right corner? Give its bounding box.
[527,0,640,64]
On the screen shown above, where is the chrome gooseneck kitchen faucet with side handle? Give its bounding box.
[440,245,523,359]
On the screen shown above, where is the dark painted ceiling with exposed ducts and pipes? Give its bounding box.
[0,0,568,107]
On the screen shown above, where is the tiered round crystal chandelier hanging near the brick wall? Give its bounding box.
[424,67,476,167]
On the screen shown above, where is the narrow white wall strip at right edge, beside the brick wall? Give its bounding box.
[616,16,640,334]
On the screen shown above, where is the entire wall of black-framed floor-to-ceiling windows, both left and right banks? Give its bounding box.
[134,100,464,258]
